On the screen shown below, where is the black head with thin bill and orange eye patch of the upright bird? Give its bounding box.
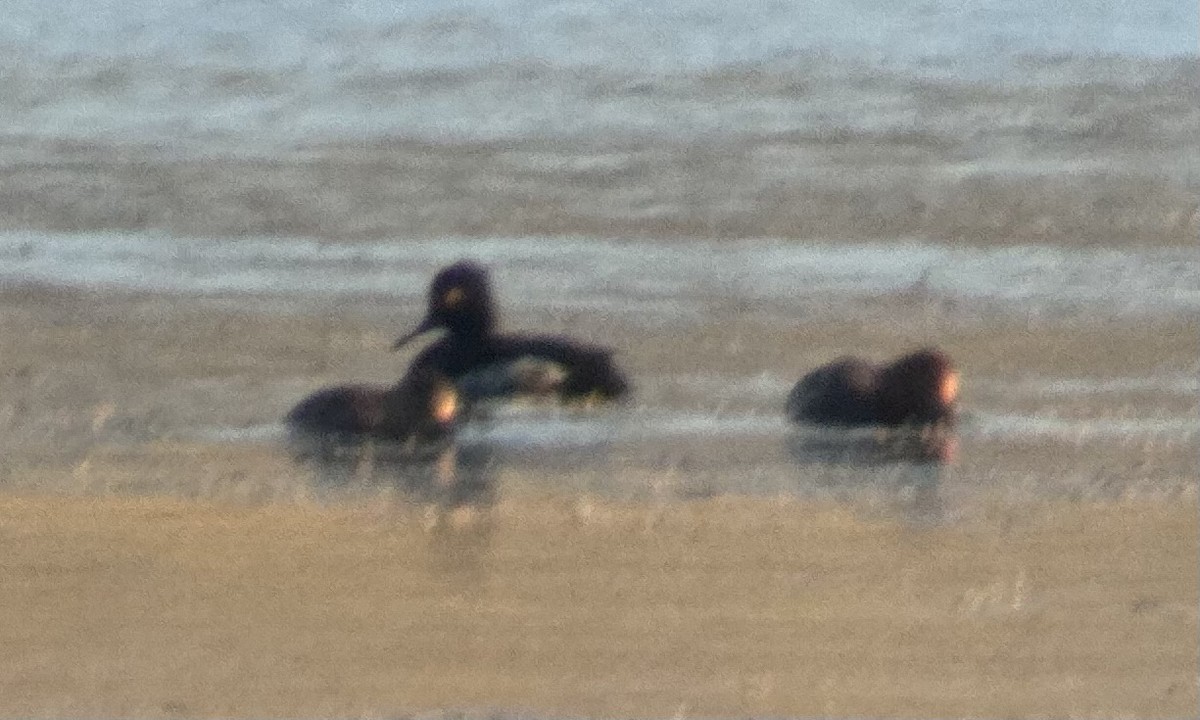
[392,260,496,349]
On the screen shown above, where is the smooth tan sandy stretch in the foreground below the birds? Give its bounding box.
[0,492,1198,718]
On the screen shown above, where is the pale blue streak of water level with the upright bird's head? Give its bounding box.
[0,233,1200,323]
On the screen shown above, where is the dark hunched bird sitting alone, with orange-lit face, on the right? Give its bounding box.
[785,348,959,428]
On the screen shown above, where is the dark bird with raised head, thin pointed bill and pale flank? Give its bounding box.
[394,260,629,402]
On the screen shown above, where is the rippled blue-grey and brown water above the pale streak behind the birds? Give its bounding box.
[0,0,1200,244]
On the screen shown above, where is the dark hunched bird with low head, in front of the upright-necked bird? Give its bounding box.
[284,370,461,461]
